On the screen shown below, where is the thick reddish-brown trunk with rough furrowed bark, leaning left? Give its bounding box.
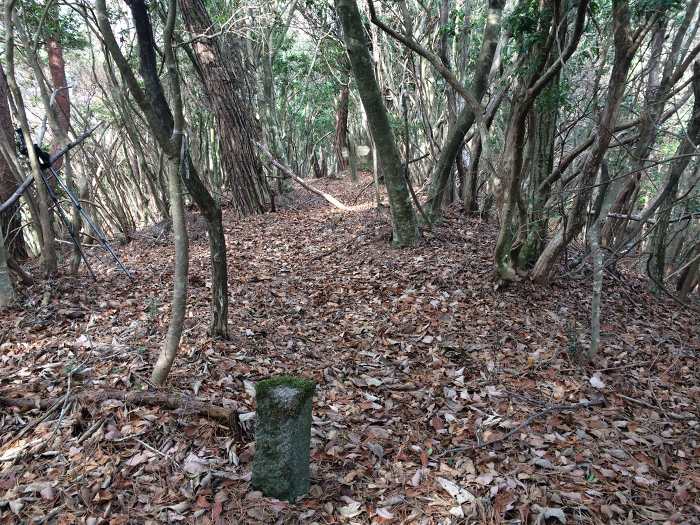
[178,0,269,215]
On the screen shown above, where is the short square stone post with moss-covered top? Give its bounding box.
[252,376,316,502]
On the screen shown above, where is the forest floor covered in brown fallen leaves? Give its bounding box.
[0,177,700,524]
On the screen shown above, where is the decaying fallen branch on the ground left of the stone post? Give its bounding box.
[0,390,242,437]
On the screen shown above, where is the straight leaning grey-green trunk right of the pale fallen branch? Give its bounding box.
[335,0,418,246]
